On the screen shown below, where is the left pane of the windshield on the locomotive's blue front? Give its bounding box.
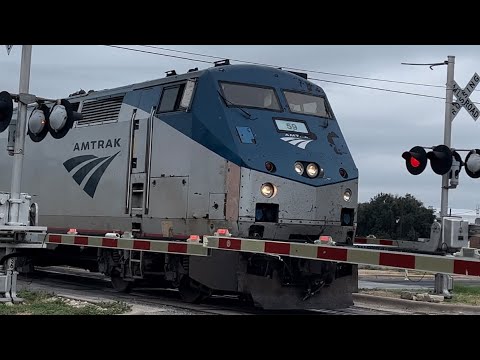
[220,83,281,111]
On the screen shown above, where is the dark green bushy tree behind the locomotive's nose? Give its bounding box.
[357,193,435,240]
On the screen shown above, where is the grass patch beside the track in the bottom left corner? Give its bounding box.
[0,290,131,315]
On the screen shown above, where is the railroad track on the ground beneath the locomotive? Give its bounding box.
[19,267,396,315]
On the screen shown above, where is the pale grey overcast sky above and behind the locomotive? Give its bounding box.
[0,45,480,209]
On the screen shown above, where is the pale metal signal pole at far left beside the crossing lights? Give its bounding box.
[7,45,32,226]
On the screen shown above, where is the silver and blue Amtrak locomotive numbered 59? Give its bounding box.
[0,61,358,309]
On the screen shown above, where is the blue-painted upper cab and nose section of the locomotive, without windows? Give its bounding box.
[71,65,358,186]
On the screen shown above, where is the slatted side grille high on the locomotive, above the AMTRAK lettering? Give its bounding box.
[77,95,123,125]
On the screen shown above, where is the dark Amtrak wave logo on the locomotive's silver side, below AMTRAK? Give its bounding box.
[63,151,120,198]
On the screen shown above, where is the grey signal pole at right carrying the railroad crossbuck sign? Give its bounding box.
[435,56,455,298]
